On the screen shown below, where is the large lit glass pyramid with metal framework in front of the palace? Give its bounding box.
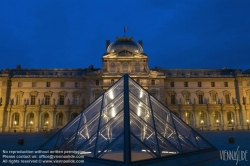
[39,74,215,164]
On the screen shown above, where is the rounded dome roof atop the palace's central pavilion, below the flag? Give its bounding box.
[107,36,143,53]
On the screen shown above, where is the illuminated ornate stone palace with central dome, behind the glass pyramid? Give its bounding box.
[0,36,250,132]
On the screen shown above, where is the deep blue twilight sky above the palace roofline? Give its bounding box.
[0,0,250,70]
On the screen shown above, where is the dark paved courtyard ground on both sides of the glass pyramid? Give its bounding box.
[0,130,250,166]
